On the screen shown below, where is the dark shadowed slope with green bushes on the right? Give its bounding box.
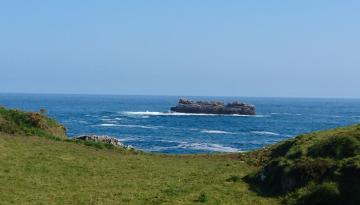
[246,125,360,205]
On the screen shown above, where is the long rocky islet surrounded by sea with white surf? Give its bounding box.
[171,98,256,115]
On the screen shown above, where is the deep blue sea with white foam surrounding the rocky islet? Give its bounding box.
[0,94,360,154]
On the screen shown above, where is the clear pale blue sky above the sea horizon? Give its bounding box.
[0,0,360,98]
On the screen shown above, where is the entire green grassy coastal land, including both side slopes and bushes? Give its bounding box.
[0,107,360,205]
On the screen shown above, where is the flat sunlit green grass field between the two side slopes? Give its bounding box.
[0,133,279,204]
